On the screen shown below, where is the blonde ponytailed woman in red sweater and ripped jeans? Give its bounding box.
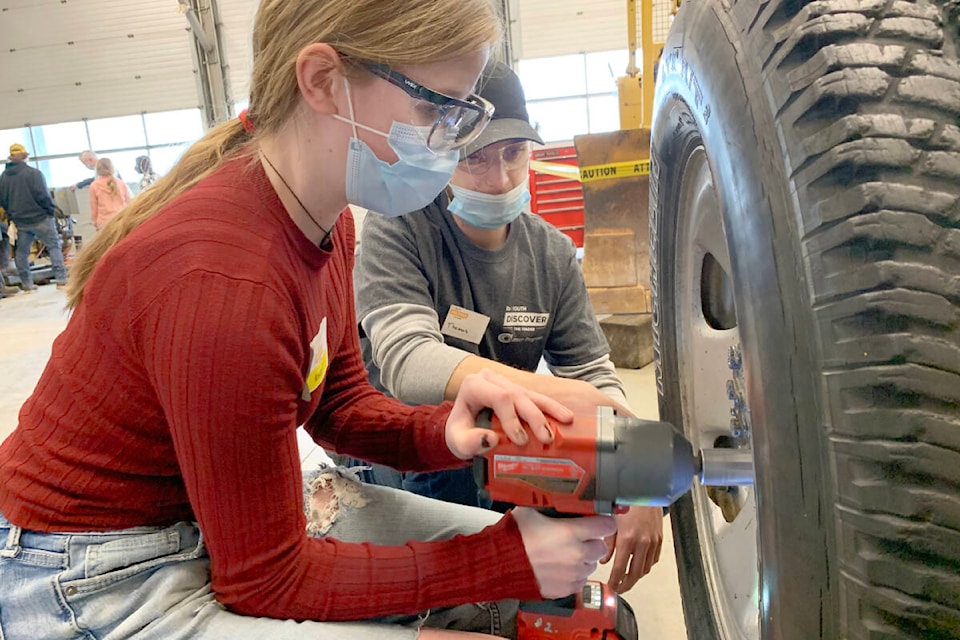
[0,0,615,640]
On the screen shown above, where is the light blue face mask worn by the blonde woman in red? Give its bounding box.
[333,82,460,217]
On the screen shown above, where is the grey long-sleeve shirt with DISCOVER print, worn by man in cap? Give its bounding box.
[354,194,626,406]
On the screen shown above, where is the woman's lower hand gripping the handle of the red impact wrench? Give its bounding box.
[511,507,617,599]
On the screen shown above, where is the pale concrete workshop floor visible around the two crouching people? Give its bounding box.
[0,285,687,640]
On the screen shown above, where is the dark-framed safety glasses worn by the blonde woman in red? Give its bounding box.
[362,62,493,153]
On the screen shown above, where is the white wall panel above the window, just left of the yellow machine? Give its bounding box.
[511,0,627,60]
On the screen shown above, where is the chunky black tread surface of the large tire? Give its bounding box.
[758,0,960,640]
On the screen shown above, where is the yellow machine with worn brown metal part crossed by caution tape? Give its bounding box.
[530,0,679,367]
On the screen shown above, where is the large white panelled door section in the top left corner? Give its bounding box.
[0,0,197,129]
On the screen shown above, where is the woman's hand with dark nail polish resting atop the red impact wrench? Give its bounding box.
[446,370,568,460]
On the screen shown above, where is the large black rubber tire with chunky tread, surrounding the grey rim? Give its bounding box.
[650,0,960,640]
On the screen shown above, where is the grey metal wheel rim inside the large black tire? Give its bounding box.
[676,146,760,640]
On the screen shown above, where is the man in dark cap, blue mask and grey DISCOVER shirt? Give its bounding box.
[354,63,663,592]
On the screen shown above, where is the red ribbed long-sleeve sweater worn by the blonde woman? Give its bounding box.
[0,160,538,620]
